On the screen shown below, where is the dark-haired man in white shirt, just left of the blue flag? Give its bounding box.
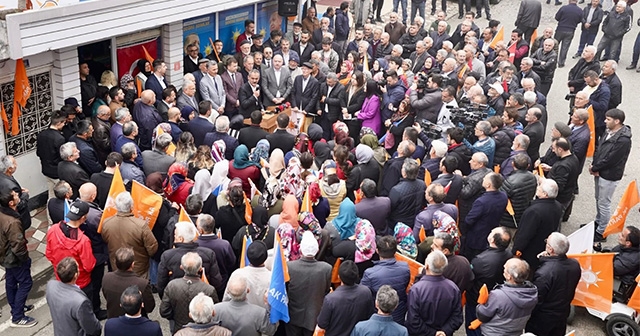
[222,240,271,309]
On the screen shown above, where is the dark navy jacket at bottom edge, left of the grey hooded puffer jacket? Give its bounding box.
[405,275,462,336]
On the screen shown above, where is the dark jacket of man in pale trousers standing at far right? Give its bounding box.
[591,125,631,181]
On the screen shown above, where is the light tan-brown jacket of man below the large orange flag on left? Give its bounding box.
[102,212,158,279]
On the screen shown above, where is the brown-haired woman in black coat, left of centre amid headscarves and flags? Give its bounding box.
[215,185,250,243]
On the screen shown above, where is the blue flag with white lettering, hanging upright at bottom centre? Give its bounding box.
[268,234,289,323]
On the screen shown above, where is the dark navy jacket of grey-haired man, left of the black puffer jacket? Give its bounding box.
[463,191,507,250]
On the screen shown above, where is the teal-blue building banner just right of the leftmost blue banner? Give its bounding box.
[218,5,255,54]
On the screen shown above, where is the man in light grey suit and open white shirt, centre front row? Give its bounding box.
[262,55,293,106]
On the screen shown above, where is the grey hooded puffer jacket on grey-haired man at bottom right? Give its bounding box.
[476,281,538,336]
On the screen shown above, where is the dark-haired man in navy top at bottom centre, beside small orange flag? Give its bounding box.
[318,260,374,336]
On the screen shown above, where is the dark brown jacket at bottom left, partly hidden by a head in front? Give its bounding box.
[102,270,156,318]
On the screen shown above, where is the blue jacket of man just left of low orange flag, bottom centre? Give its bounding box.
[358,259,411,324]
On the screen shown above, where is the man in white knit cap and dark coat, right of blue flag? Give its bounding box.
[285,231,332,336]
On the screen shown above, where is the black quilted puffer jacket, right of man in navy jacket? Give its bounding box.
[500,170,538,228]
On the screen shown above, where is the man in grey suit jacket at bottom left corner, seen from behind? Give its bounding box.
[46,257,102,335]
